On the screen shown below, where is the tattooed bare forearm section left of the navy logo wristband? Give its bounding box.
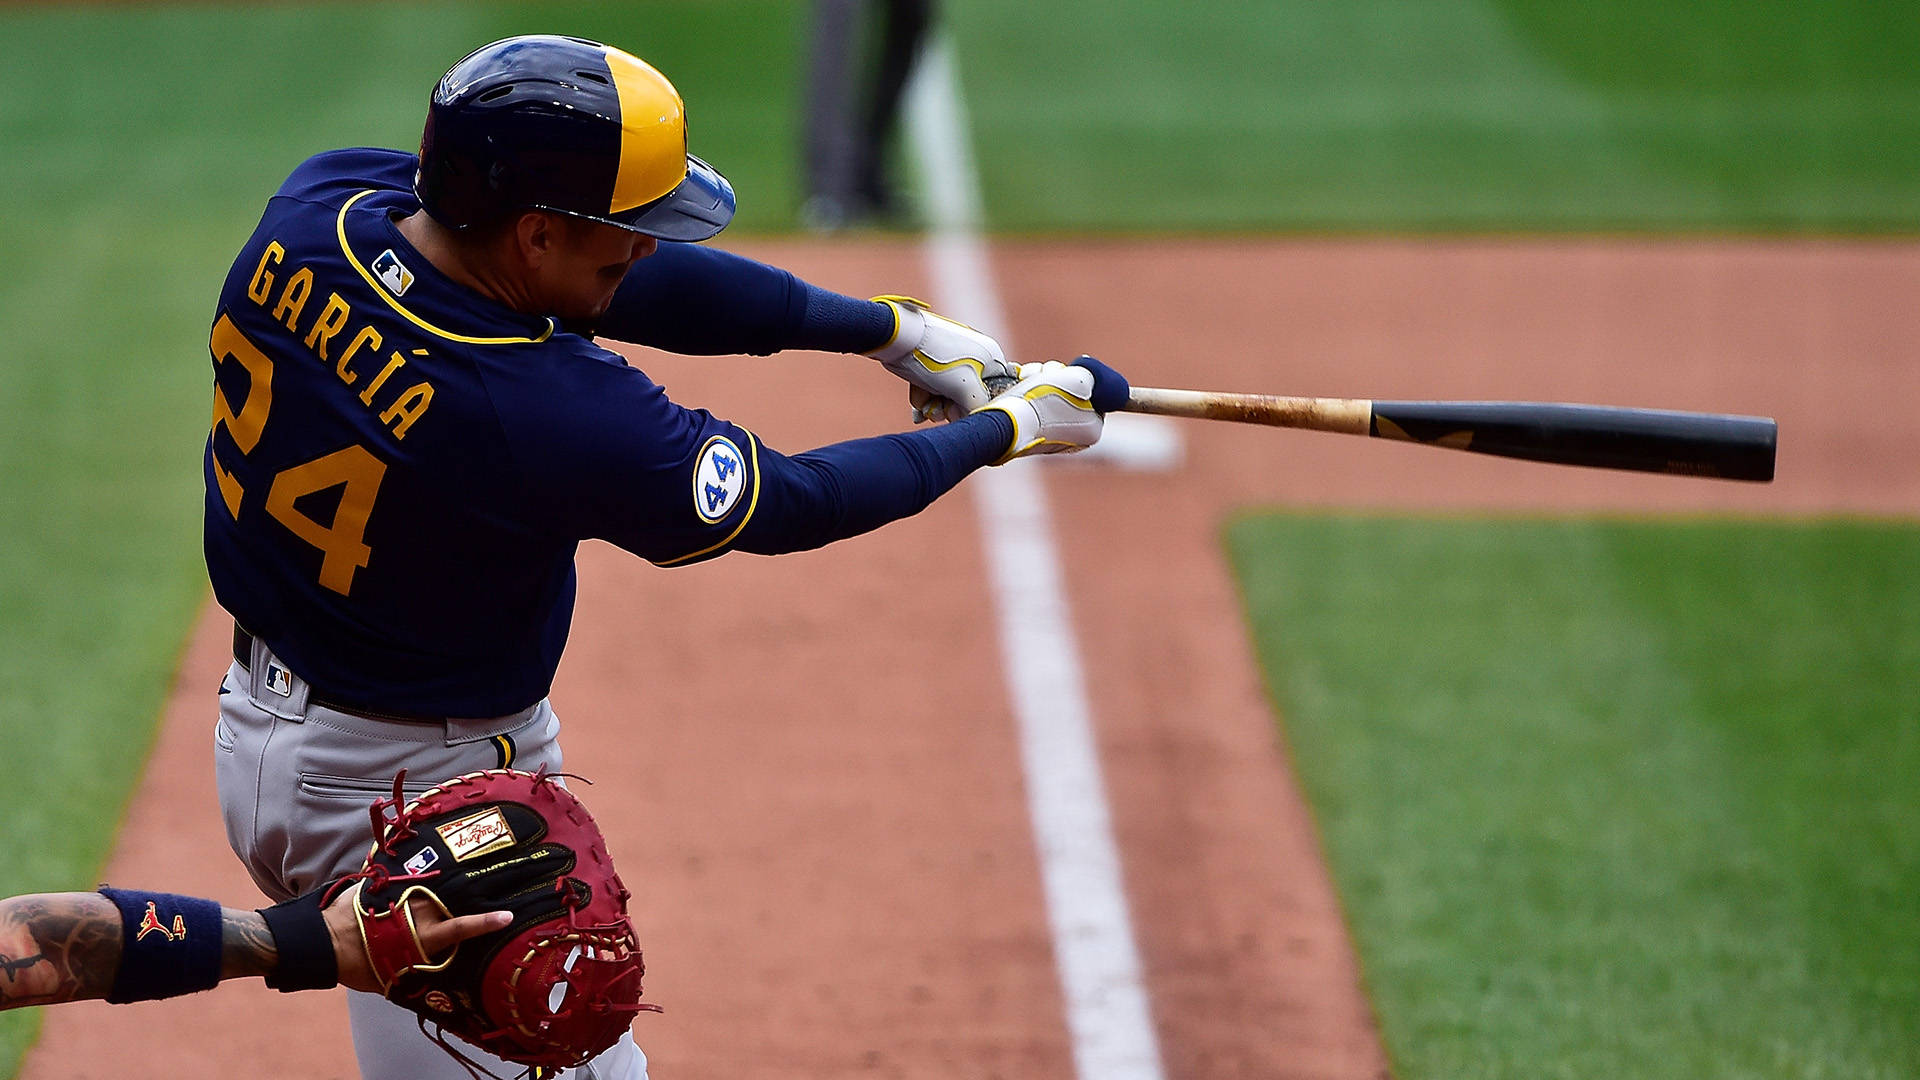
[0,892,121,1009]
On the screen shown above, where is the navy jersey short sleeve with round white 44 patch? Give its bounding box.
[490,346,760,565]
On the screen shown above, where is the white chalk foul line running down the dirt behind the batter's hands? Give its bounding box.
[906,37,1162,1080]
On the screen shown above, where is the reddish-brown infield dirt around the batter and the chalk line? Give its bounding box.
[23,240,1920,1080]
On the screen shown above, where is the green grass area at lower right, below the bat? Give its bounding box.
[1229,515,1920,1080]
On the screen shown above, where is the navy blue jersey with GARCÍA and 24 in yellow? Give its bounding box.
[205,150,762,717]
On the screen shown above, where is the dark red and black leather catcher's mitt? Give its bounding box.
[328,769,659,1074]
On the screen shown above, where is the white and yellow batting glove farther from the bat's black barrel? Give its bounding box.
[868,296,1020,423]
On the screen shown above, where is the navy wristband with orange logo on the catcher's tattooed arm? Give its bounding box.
[100,886,221,1005]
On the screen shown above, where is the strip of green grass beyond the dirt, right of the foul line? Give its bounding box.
[948,0,1920,233]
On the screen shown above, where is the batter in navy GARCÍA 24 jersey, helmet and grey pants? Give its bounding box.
[205,35,1127,1080]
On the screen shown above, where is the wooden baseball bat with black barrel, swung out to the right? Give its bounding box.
[1125,386,1778,474]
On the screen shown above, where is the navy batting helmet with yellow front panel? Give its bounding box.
[413,35,733,240]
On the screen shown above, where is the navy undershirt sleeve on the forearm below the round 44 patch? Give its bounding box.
[732,409,1014,555]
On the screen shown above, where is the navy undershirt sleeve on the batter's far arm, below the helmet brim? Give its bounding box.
[587,242,893,356]
